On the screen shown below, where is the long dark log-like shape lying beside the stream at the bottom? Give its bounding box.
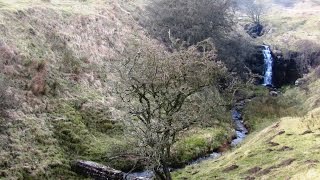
[72,160,125,180]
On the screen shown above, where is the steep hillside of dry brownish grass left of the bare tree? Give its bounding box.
[0,0,156,179]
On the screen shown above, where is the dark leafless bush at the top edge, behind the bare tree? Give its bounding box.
[142,0,232,45]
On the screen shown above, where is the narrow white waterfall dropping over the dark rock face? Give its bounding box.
[262,45,273,86]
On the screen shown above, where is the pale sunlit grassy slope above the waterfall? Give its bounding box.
[261,0,320,48]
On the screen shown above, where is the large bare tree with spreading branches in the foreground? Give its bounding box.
[118,41,226,180]
